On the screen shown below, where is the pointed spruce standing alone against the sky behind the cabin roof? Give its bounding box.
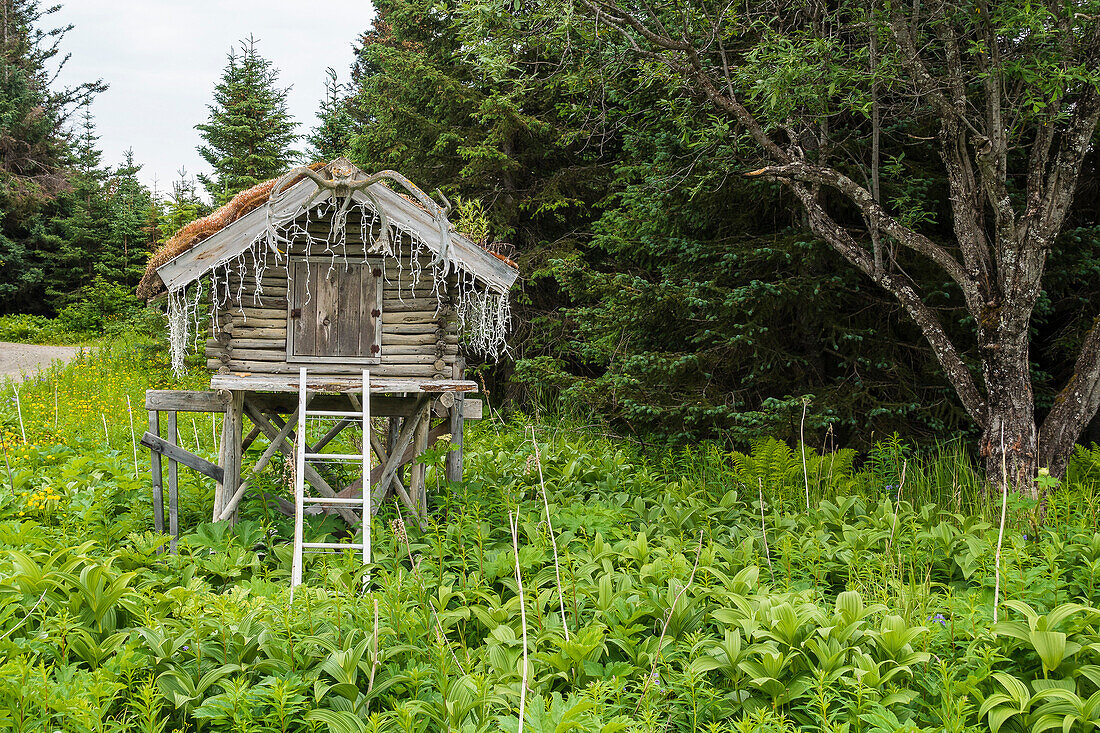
[195,36,299,204]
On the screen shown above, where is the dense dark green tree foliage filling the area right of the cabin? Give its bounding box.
[322,0,1100,457]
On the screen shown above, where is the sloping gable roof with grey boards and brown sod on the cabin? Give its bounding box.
[138,159,519,297]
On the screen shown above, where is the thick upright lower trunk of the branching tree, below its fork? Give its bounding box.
[978,313,1038,499]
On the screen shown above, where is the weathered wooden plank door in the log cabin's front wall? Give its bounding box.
[287,259,382,363]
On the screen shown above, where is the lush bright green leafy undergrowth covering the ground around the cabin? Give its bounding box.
[0,340,1100,733]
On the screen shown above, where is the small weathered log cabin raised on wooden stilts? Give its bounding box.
[139,158,518,548]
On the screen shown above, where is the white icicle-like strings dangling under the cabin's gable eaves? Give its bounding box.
[168,167,510,374]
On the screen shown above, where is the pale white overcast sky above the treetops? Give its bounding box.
[52,0,374,198]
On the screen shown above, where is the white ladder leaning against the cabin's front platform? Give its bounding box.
[290,367,371,589]
